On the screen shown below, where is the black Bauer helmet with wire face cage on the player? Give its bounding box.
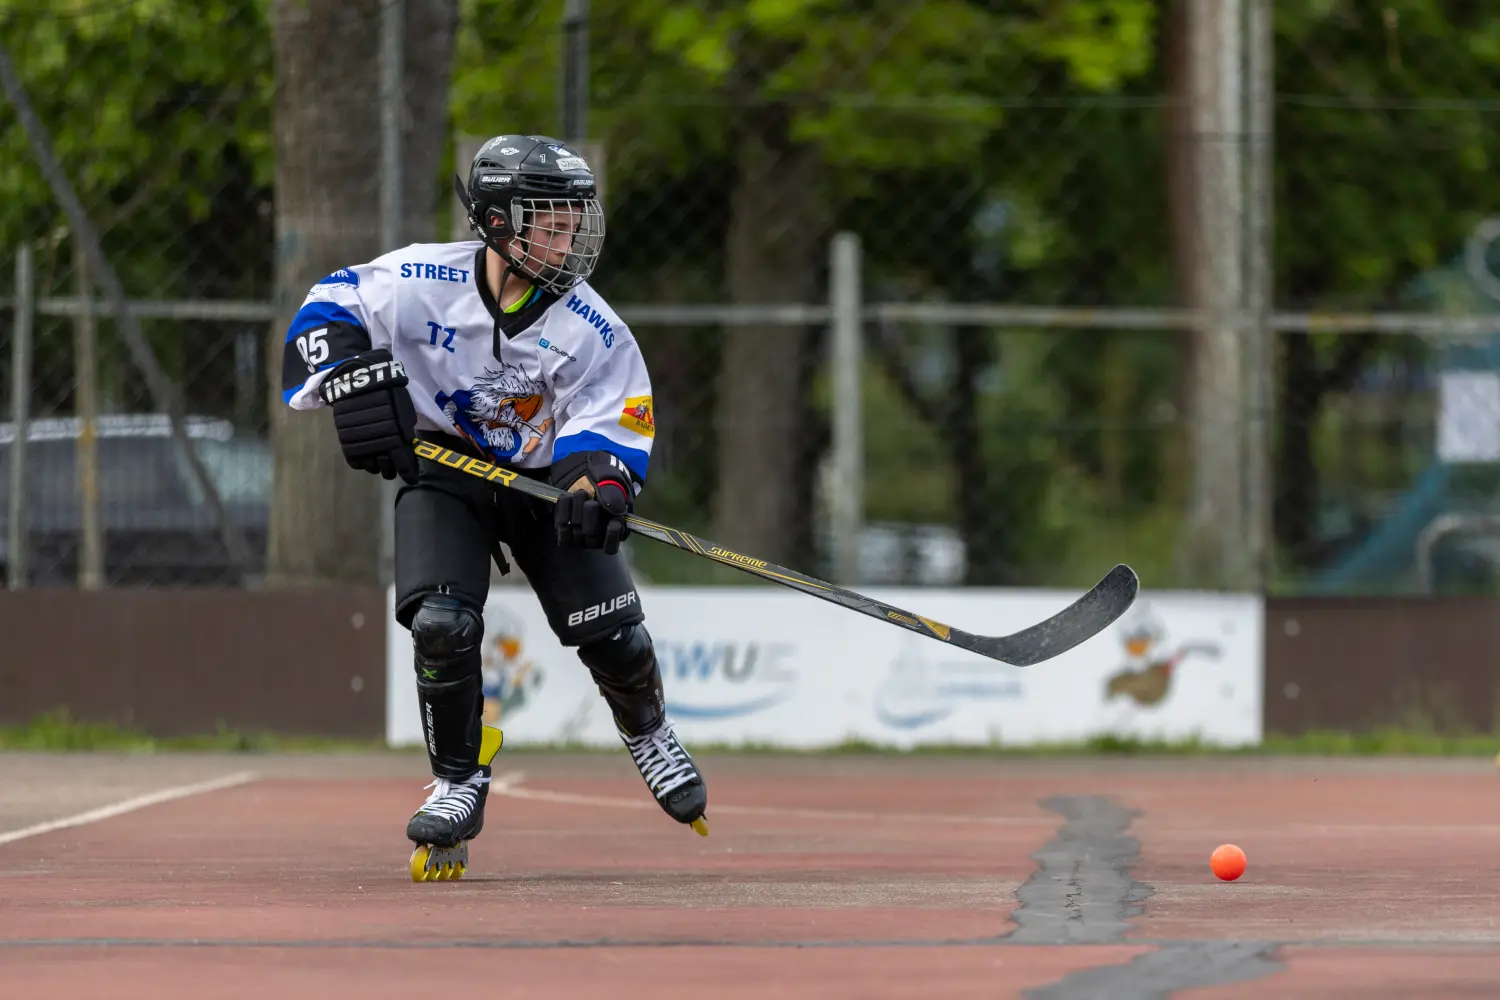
[453,135,605,295]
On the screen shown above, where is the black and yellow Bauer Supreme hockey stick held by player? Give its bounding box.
[416,438,1140,667]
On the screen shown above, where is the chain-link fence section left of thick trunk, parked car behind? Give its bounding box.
[0,0,275,586]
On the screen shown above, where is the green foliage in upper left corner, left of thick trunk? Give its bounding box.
[0,0,272,297]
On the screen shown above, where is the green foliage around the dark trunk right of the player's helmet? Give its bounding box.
[453,0,1157,581]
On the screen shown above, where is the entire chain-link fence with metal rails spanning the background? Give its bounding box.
[0,0,1500,592]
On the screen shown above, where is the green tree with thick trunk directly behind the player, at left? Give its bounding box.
[0,0,456,583]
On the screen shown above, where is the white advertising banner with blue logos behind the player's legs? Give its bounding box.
[387,586,1263,748]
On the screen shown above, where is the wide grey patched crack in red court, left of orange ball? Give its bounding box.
[1004,795,1283,1000]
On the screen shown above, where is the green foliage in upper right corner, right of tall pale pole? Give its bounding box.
[1275,0,1500,307]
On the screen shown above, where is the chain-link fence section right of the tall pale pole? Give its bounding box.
[1272,1,1500,592]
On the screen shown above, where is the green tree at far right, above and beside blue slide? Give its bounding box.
[1274,0,1500,571]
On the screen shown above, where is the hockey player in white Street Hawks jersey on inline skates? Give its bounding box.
[282,135,708,879]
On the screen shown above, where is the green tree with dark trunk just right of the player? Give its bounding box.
[455,0,1152,578]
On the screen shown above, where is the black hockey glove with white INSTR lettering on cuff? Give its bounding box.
[318,348,417,483]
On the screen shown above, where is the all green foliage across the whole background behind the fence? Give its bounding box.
[0,0,1500,583]
